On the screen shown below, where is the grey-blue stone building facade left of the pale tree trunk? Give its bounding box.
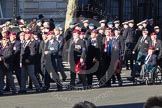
[1,0,67,21]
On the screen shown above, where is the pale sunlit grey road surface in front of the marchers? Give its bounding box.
[0,62,162,108]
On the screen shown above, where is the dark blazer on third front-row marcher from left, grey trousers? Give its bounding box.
[20,40,36,65]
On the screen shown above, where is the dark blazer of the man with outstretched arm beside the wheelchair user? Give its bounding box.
[134,36,151,53]
